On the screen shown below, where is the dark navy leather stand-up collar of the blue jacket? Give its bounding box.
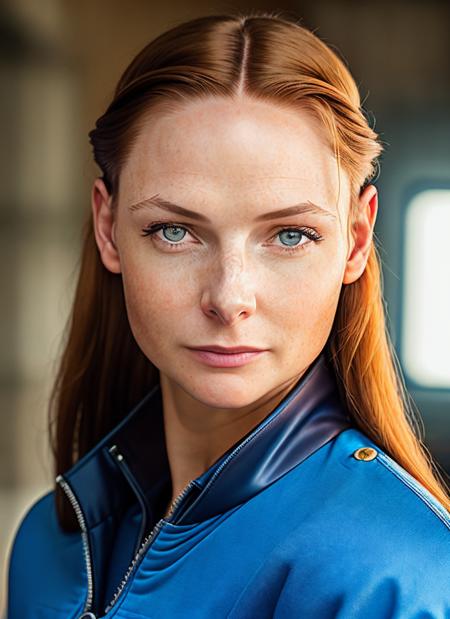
[59,352,354,529]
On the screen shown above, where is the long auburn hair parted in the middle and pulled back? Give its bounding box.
[49,11,450,530]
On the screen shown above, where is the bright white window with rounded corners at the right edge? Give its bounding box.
[401,189,450,389]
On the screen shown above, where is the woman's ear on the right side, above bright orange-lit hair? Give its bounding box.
[342,185,378,284]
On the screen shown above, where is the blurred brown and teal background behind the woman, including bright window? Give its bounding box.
[0,0,450,614]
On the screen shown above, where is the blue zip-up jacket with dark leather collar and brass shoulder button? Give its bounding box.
[7,353,450,619]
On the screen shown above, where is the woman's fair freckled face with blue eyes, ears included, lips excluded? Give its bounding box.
[93,98,377,408]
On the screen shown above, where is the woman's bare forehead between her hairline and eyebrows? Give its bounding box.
[120,98,343,220]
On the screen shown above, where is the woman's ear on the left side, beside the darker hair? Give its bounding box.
[91,178,121,273]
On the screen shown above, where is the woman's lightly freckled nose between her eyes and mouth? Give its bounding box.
[200,251,256,325]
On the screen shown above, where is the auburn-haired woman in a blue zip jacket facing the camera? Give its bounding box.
[8,13,450,619]
